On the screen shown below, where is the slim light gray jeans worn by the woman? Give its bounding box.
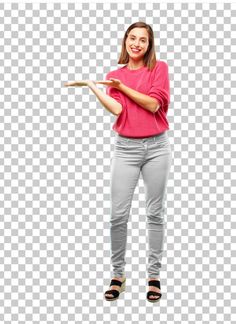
[110,131,172,278]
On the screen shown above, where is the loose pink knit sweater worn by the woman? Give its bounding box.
[106,61,170,138]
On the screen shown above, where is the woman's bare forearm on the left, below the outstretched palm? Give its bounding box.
[89,83,122,116]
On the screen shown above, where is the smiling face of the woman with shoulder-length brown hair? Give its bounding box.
[125,27,149,62]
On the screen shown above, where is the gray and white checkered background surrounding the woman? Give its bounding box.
[0,2,236,324]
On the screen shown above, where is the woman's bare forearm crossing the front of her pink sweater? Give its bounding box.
[119,84,160,113]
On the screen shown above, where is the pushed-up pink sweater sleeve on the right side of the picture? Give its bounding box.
[148,61,170,113]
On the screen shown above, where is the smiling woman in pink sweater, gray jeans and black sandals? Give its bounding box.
[66,22,172,302]
